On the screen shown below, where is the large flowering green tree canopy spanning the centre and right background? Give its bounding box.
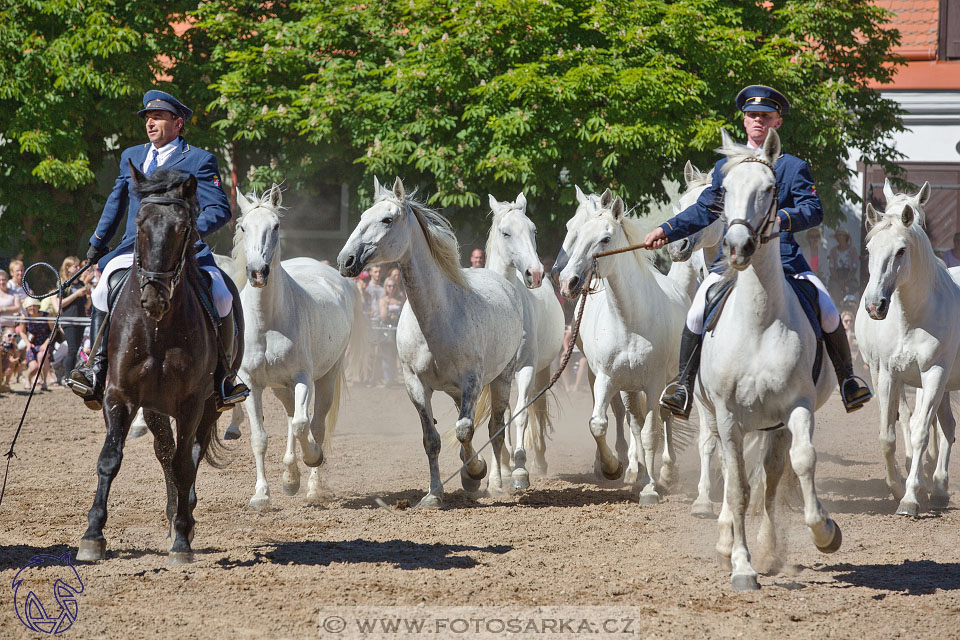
[196,0,901,235]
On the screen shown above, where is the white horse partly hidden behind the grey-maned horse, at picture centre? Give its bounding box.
[486,193,564,489]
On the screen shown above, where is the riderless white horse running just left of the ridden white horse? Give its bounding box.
[554,189,690,504]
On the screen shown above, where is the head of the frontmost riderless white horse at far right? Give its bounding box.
[863,181,933,320]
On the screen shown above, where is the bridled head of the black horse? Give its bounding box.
[129,162,200,321]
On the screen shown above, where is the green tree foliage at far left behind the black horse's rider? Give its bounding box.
[0,0,195,257]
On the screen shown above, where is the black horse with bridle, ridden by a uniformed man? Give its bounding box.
[77,164,243,563]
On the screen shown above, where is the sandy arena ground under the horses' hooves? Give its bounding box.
[0,380,960,640]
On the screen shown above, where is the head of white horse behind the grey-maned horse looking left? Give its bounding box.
[487,193,543,289]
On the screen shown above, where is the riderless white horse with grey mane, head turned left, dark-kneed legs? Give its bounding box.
[337,178,523,507]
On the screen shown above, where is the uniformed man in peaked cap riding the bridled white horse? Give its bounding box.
[645,85,872,418]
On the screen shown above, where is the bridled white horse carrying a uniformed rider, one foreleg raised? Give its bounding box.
[695,130,842,590]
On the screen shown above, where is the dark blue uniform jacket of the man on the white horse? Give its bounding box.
[660,153,823,275]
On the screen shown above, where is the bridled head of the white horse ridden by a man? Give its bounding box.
[718,129,780,271]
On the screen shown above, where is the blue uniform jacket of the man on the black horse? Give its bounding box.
[90,138,231,270]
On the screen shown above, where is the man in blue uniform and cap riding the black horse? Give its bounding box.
[67,90,250,411]
